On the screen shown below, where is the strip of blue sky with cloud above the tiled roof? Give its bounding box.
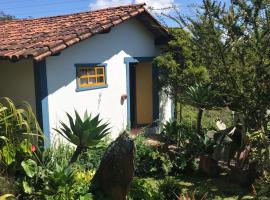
[0,0,229,25]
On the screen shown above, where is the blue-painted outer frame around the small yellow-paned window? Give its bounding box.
[75,63,108,92]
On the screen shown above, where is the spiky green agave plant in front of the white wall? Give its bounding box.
[54,111,110,164]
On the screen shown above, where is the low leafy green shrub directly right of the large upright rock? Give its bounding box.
[135,136,172,176]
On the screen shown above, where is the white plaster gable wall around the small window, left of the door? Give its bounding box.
[47,19,172,139]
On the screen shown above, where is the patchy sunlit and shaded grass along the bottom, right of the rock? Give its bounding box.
[137,173,254,200]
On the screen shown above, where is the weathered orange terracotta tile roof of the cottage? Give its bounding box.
[0,4,166,61]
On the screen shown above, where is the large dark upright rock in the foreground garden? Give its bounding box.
[93,132,135,200]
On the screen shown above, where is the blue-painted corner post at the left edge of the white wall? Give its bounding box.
[34,60,50,147]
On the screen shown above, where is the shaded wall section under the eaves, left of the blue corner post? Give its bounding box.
[0,59,36,113]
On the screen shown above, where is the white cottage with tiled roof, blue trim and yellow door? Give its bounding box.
[0,4,172,143]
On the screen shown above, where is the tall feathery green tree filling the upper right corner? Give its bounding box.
[172,0,270,131]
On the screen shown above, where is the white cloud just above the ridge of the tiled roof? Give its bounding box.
[89,0,175,13]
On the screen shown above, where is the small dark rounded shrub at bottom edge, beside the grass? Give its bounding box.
[158,177,180,200]
